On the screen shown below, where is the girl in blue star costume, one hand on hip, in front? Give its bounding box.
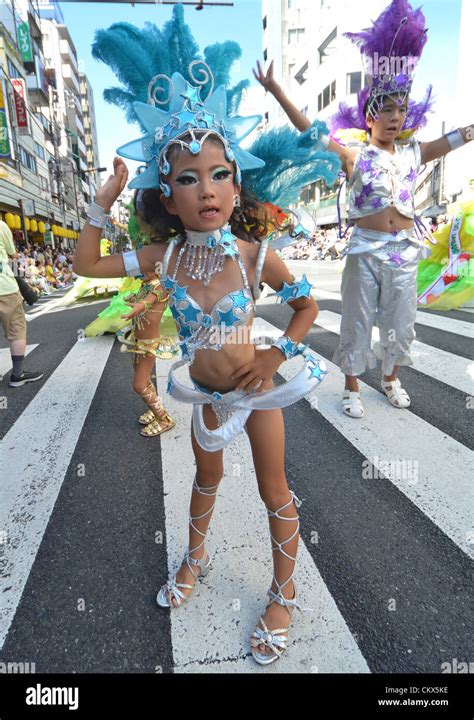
[74,54,337,664]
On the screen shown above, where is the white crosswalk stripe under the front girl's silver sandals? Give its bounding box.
[156,361,370,674]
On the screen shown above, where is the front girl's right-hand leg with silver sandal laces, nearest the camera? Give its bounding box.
[247,409,299,655]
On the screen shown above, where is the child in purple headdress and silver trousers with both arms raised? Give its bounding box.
[254,0,474,418]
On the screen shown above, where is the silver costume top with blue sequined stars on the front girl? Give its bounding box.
[161,232,255,362]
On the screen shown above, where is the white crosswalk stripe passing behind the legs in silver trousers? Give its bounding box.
[314,310,474,395]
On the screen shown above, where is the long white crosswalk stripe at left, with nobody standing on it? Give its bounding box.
[0,337,114,650]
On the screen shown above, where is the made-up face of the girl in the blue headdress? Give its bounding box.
[161,140,240,232]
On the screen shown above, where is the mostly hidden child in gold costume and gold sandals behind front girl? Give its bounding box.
[122,273,176,437]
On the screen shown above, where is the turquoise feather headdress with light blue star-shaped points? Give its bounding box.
[92,5,340,205]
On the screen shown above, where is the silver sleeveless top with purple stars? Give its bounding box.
[347,138,421,220]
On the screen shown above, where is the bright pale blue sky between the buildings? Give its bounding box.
[60,0,462,179]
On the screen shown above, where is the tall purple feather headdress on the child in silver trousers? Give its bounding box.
[331,0,432,133]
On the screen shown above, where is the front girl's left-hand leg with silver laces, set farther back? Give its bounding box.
[168,405,224,607]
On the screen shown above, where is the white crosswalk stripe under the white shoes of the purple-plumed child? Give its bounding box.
[254,318,474,557]
